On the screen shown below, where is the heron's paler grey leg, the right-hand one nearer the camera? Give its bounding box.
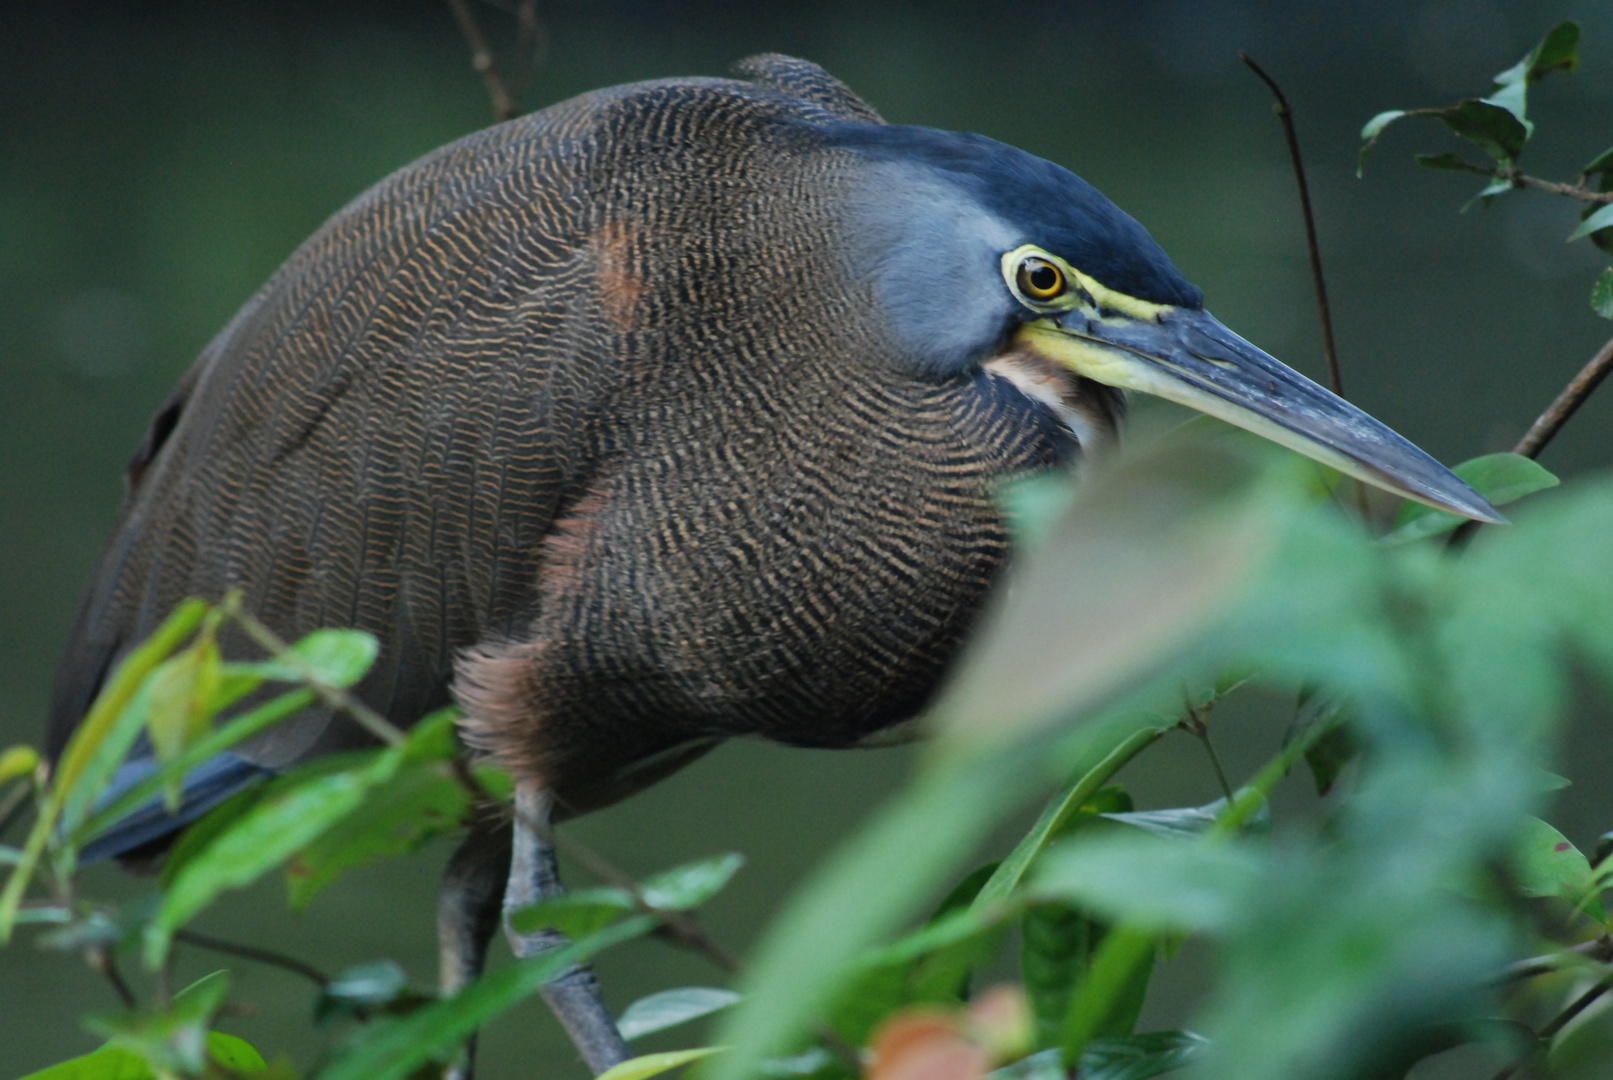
[503,780,627,1075]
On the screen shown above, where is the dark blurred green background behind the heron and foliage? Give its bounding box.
[0,0,1613,1080]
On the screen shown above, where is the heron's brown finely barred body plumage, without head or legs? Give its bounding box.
[52,56,1119,822]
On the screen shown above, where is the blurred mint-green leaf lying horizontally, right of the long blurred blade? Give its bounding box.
[1031,832,1261,930]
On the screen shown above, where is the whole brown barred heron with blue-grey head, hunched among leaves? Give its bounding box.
[52,56,1497,1070]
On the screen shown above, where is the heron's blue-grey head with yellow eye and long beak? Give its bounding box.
[831,124,1505,522]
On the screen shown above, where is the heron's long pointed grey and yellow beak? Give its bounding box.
[1016,308,1507,522]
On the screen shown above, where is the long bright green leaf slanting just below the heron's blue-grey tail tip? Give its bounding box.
[145,743,408,969]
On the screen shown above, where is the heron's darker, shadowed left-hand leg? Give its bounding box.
[437,814,510,1080]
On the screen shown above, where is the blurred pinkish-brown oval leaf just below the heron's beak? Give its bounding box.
[935,427,1271,754]
